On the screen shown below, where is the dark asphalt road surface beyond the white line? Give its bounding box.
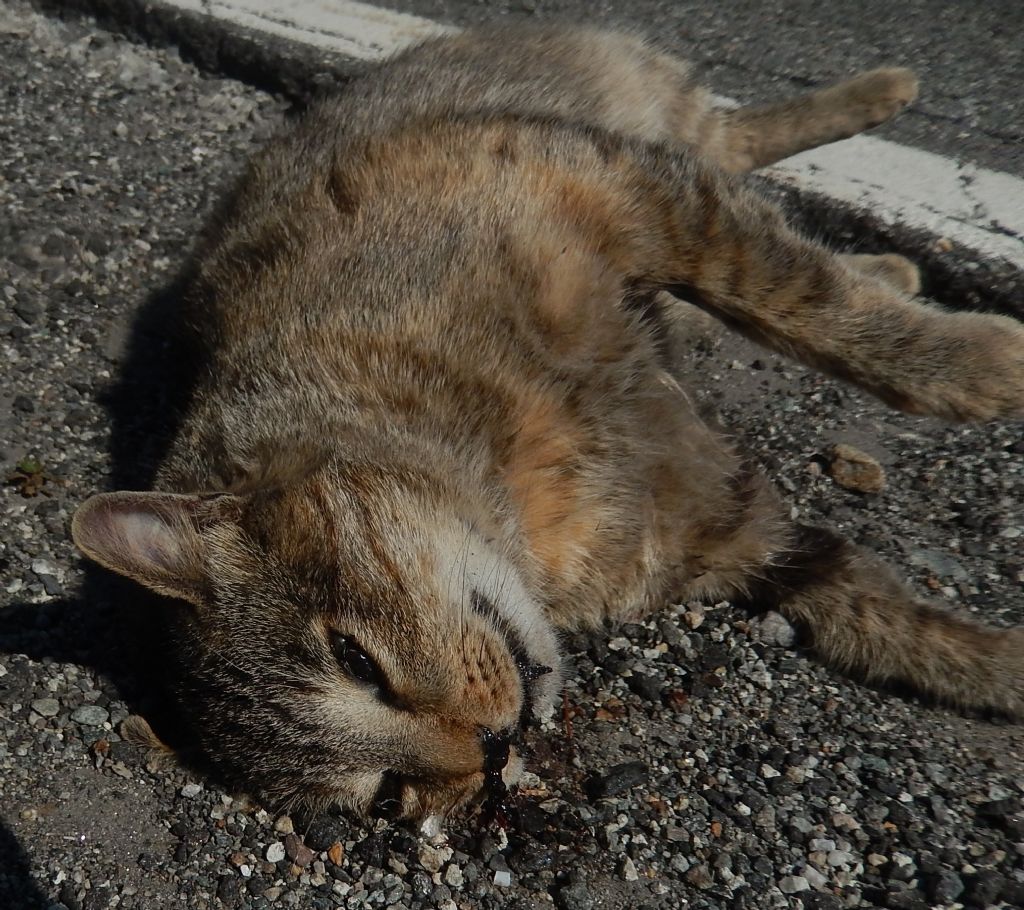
[381,0,1024,176]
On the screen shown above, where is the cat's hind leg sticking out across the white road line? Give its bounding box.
[702,68,918,173]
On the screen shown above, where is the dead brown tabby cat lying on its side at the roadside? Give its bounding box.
[73,26,1024,830]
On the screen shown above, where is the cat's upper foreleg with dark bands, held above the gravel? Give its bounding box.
[585,138,1024,421]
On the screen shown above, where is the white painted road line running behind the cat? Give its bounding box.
[162,0,1024,269]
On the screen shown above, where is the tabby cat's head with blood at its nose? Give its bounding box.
[73,471,559,820]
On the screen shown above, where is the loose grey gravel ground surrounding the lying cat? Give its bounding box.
[0,3,1024,910]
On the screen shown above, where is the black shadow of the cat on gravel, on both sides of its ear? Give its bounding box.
[0,262,209,753]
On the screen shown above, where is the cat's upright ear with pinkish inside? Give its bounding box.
[71,492,238,605]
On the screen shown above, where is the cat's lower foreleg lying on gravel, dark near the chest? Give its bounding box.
[750,525,1024,718]
